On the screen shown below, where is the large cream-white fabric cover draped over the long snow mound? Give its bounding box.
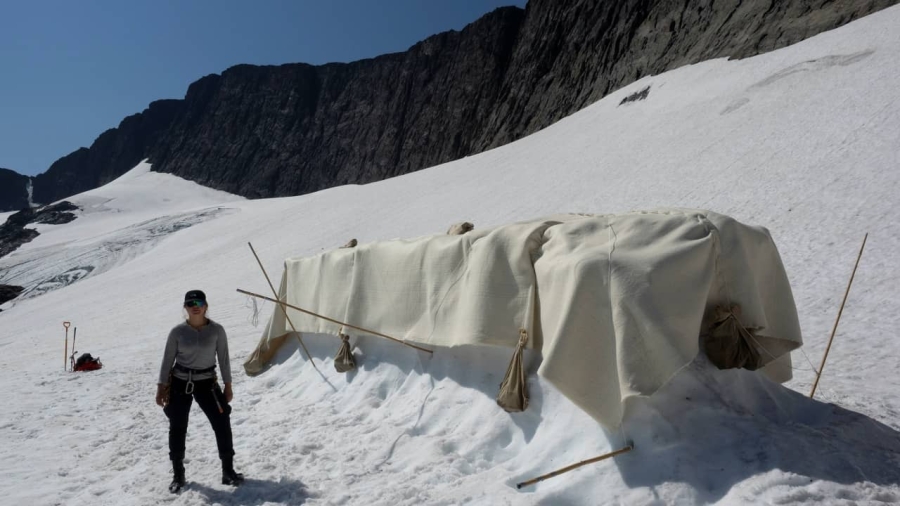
[245,209,802,427]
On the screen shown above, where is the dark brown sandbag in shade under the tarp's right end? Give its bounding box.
[703,305,763,371]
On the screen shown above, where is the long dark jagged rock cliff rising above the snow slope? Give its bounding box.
[3,0,898,207]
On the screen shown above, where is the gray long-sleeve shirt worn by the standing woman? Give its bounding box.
[159,319,231,384]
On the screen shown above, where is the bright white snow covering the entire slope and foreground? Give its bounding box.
[0,7,900,505]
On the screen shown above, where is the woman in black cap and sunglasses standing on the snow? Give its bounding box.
[156,290,244,493]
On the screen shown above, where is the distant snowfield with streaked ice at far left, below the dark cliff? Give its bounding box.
[0,163,243,300]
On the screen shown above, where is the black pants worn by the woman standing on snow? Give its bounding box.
[163,377,234,460]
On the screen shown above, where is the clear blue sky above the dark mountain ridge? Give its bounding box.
[0,0,525,175]
